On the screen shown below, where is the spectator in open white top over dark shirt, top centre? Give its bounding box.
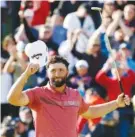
[63,4,95,53]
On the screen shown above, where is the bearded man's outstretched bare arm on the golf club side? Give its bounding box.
[82,93,130,119]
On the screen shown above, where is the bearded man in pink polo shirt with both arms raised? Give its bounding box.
[8,56,130,137]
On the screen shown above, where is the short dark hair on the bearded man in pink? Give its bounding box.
[46,56,69,69]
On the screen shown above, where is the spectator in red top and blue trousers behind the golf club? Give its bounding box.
[96,59,135,137]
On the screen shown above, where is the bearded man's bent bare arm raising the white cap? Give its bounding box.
[7,64,39,106]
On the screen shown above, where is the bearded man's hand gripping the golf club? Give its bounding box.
[116,93,130,107]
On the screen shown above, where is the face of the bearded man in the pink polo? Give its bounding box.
[47,63,68,87]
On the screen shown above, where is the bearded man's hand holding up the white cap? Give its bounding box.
[24,63,39,76]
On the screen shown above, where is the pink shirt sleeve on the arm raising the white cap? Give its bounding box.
[24,87,40,108]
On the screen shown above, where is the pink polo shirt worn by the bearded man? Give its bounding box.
[26,84,89,137]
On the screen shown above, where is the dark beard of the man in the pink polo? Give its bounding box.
[50,77,66,87]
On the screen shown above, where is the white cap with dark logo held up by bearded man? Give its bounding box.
[25,40,48,67]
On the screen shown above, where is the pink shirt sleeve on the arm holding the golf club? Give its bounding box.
[79,98,89,115]
